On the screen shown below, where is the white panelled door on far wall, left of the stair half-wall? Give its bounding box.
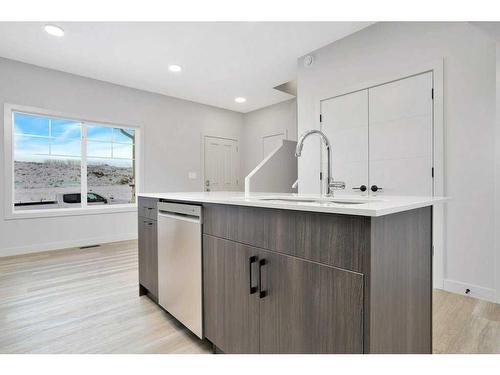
[204,136,240,191]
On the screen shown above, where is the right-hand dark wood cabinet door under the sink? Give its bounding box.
[259,251,363,353]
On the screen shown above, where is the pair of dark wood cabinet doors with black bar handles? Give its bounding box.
[204,235,363,353]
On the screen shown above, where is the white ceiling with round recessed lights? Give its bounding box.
[0,22,371,112]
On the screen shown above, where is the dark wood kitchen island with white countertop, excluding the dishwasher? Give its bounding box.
[138,192,445,353]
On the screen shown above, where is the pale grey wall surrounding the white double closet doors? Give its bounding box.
[297,23,500,298]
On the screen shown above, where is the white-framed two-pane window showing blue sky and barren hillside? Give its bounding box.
[12,112,136,211]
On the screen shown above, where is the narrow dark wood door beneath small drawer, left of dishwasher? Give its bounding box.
[139,217,158,299]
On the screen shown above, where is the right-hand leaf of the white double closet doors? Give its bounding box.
[368,72,433,195]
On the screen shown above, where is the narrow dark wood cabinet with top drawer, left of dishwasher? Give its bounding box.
[138,198,158,301]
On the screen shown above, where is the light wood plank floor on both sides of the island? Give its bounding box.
[0,241,500,353]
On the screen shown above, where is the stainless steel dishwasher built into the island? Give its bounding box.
[158,201,203,338]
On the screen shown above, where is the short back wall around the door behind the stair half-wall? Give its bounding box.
[241,99,297,176]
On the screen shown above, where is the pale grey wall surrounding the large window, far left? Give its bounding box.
[0,58,243,256]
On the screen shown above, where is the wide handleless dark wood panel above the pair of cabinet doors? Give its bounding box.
[203,204,370,272]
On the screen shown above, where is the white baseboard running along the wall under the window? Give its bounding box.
[0,233,137,258]
